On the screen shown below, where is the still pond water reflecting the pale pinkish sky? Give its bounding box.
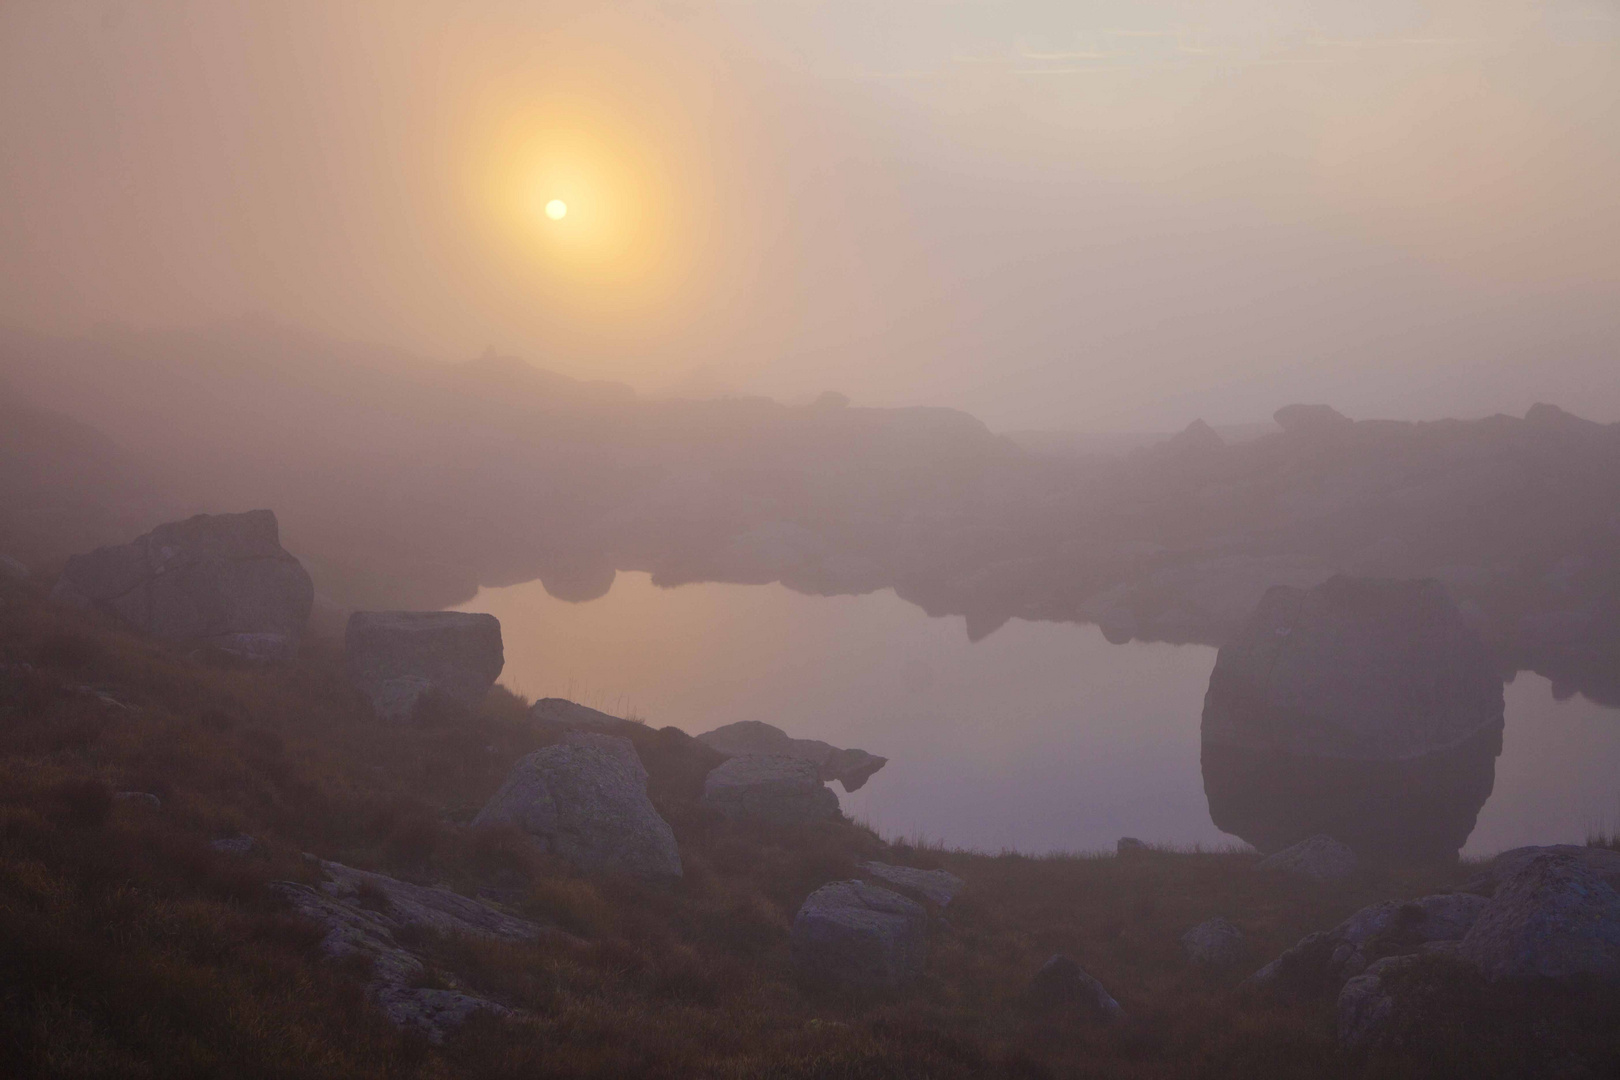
[463,573,1620,855]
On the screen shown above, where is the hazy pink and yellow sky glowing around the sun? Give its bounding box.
[0,0,1620,429]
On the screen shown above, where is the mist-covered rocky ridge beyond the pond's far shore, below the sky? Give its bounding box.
[9,321,1620,704]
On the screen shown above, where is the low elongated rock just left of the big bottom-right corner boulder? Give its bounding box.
[1249,892,1486,993]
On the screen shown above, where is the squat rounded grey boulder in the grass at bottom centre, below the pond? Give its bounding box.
[792,881,928,989]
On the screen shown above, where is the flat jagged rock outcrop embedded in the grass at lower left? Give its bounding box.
[272,863,541,1043]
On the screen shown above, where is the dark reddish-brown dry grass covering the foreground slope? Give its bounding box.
[0,573,1620,1080]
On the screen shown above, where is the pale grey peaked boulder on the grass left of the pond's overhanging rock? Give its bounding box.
[473,732,680,878]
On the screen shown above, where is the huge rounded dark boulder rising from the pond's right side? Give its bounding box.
[1202,576,1503,861]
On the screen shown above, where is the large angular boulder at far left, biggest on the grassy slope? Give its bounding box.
[52,510,314,659]
